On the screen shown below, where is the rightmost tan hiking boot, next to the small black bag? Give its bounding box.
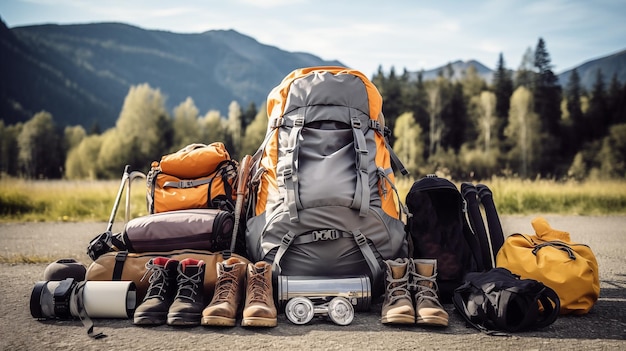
[411,259,448,327]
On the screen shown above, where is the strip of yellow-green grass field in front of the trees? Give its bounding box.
[0,178,626,222]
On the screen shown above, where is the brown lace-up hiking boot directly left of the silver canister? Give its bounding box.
[241,261,277,327]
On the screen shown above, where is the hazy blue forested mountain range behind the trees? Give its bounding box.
[0,17,626,129]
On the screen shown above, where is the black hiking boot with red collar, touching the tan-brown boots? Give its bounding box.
[167,258,206,325]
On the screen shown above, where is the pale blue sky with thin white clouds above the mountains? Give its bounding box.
[0,0,626,75]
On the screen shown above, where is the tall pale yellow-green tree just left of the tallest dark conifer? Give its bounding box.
[504,86,541,178]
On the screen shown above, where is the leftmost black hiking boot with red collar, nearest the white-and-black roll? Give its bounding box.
[133,257,178,325]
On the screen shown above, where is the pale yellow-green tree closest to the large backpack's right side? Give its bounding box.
[393,112,424,174]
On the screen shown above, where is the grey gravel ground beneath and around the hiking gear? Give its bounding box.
[0,216,626,351]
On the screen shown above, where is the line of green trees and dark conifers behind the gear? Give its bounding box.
[0,38,626,179]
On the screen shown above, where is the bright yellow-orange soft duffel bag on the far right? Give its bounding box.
[496,217,600,314]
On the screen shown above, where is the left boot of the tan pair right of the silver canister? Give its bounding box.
[381,258,415,324]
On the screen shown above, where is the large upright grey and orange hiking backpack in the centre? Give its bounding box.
[241,67,408,295]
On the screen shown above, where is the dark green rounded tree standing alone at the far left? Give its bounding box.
[17,111,62,178]
